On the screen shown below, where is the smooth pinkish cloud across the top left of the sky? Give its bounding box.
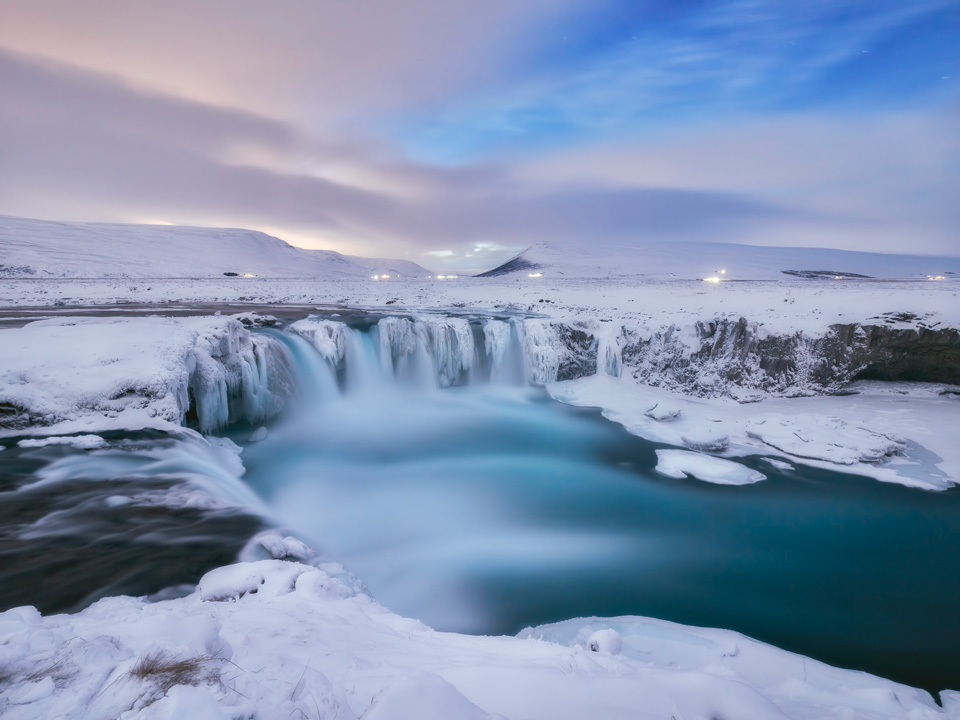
[0,0,573,125]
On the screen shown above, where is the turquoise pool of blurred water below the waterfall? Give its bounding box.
[238,334,960,690]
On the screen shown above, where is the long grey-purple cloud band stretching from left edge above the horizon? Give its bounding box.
[0,54,808,270]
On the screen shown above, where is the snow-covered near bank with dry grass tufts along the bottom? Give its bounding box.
[0,552,960,720]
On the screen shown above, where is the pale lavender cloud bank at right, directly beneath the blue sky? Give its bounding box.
[513,111,960,255]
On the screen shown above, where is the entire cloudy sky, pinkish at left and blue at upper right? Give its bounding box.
[0,0,960,272]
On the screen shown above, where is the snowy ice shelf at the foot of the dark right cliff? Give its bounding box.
[547,375,960,490]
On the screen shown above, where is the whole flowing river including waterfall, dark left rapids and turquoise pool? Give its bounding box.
[0,312,960,690]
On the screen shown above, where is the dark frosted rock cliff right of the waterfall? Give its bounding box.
[554,318,960,401]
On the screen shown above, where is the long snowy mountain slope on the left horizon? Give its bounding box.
[0,215,431,279]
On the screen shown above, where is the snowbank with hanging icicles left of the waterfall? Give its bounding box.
[0,316,289,434]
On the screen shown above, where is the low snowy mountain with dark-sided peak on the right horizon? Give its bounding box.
[477,242,960,280]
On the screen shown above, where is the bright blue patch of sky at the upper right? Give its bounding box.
[394,0,960,162]
